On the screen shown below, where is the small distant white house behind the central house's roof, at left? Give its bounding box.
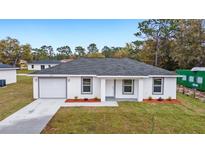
[28,60,61,70]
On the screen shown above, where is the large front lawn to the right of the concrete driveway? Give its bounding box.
[42,94,205,134]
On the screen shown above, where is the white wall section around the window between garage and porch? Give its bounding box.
[67,77,101,99]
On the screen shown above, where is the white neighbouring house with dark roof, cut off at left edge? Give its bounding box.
[0,64,17,84]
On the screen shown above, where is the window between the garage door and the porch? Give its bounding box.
[82,78,92,94]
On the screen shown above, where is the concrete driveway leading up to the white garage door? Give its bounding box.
[0,99,64,134]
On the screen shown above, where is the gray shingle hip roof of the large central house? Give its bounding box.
[32,58,175,76]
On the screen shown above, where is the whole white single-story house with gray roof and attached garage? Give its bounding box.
[31,58,177,102]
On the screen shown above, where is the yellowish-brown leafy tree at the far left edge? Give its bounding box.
[0,37,31,66]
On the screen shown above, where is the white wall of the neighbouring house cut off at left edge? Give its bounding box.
[0,69,16,84]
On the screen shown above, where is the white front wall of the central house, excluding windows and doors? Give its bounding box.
[33,76,176,101]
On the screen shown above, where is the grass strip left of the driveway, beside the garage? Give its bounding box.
[0,76,33,120]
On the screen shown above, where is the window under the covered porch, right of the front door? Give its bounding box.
[122,80,134,94]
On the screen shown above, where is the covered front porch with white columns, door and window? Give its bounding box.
[100,77,144,102]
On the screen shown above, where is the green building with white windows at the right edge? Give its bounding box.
[176,67,205,91]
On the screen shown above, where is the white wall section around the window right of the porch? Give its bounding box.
[144,77,176,99]
